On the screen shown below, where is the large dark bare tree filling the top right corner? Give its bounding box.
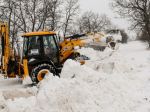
[113,0,150,41]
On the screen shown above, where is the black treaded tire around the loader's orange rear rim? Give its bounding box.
[30,64,56,83]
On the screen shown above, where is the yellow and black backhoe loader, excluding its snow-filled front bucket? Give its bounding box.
[0,22,84,83]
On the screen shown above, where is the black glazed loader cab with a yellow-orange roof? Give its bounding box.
[23,32,59,64]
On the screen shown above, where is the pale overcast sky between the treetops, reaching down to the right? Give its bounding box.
[79,0,129,29]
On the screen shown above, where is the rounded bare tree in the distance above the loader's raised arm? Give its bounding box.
[78,11,111,32]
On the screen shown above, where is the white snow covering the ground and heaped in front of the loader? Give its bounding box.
[0,41,150,112]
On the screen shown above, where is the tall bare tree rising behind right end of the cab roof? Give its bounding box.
[42,0,63,31]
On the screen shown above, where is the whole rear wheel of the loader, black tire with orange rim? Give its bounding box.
[30,64,56,83]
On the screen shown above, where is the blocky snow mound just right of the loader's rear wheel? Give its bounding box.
[61,60,102,83]
